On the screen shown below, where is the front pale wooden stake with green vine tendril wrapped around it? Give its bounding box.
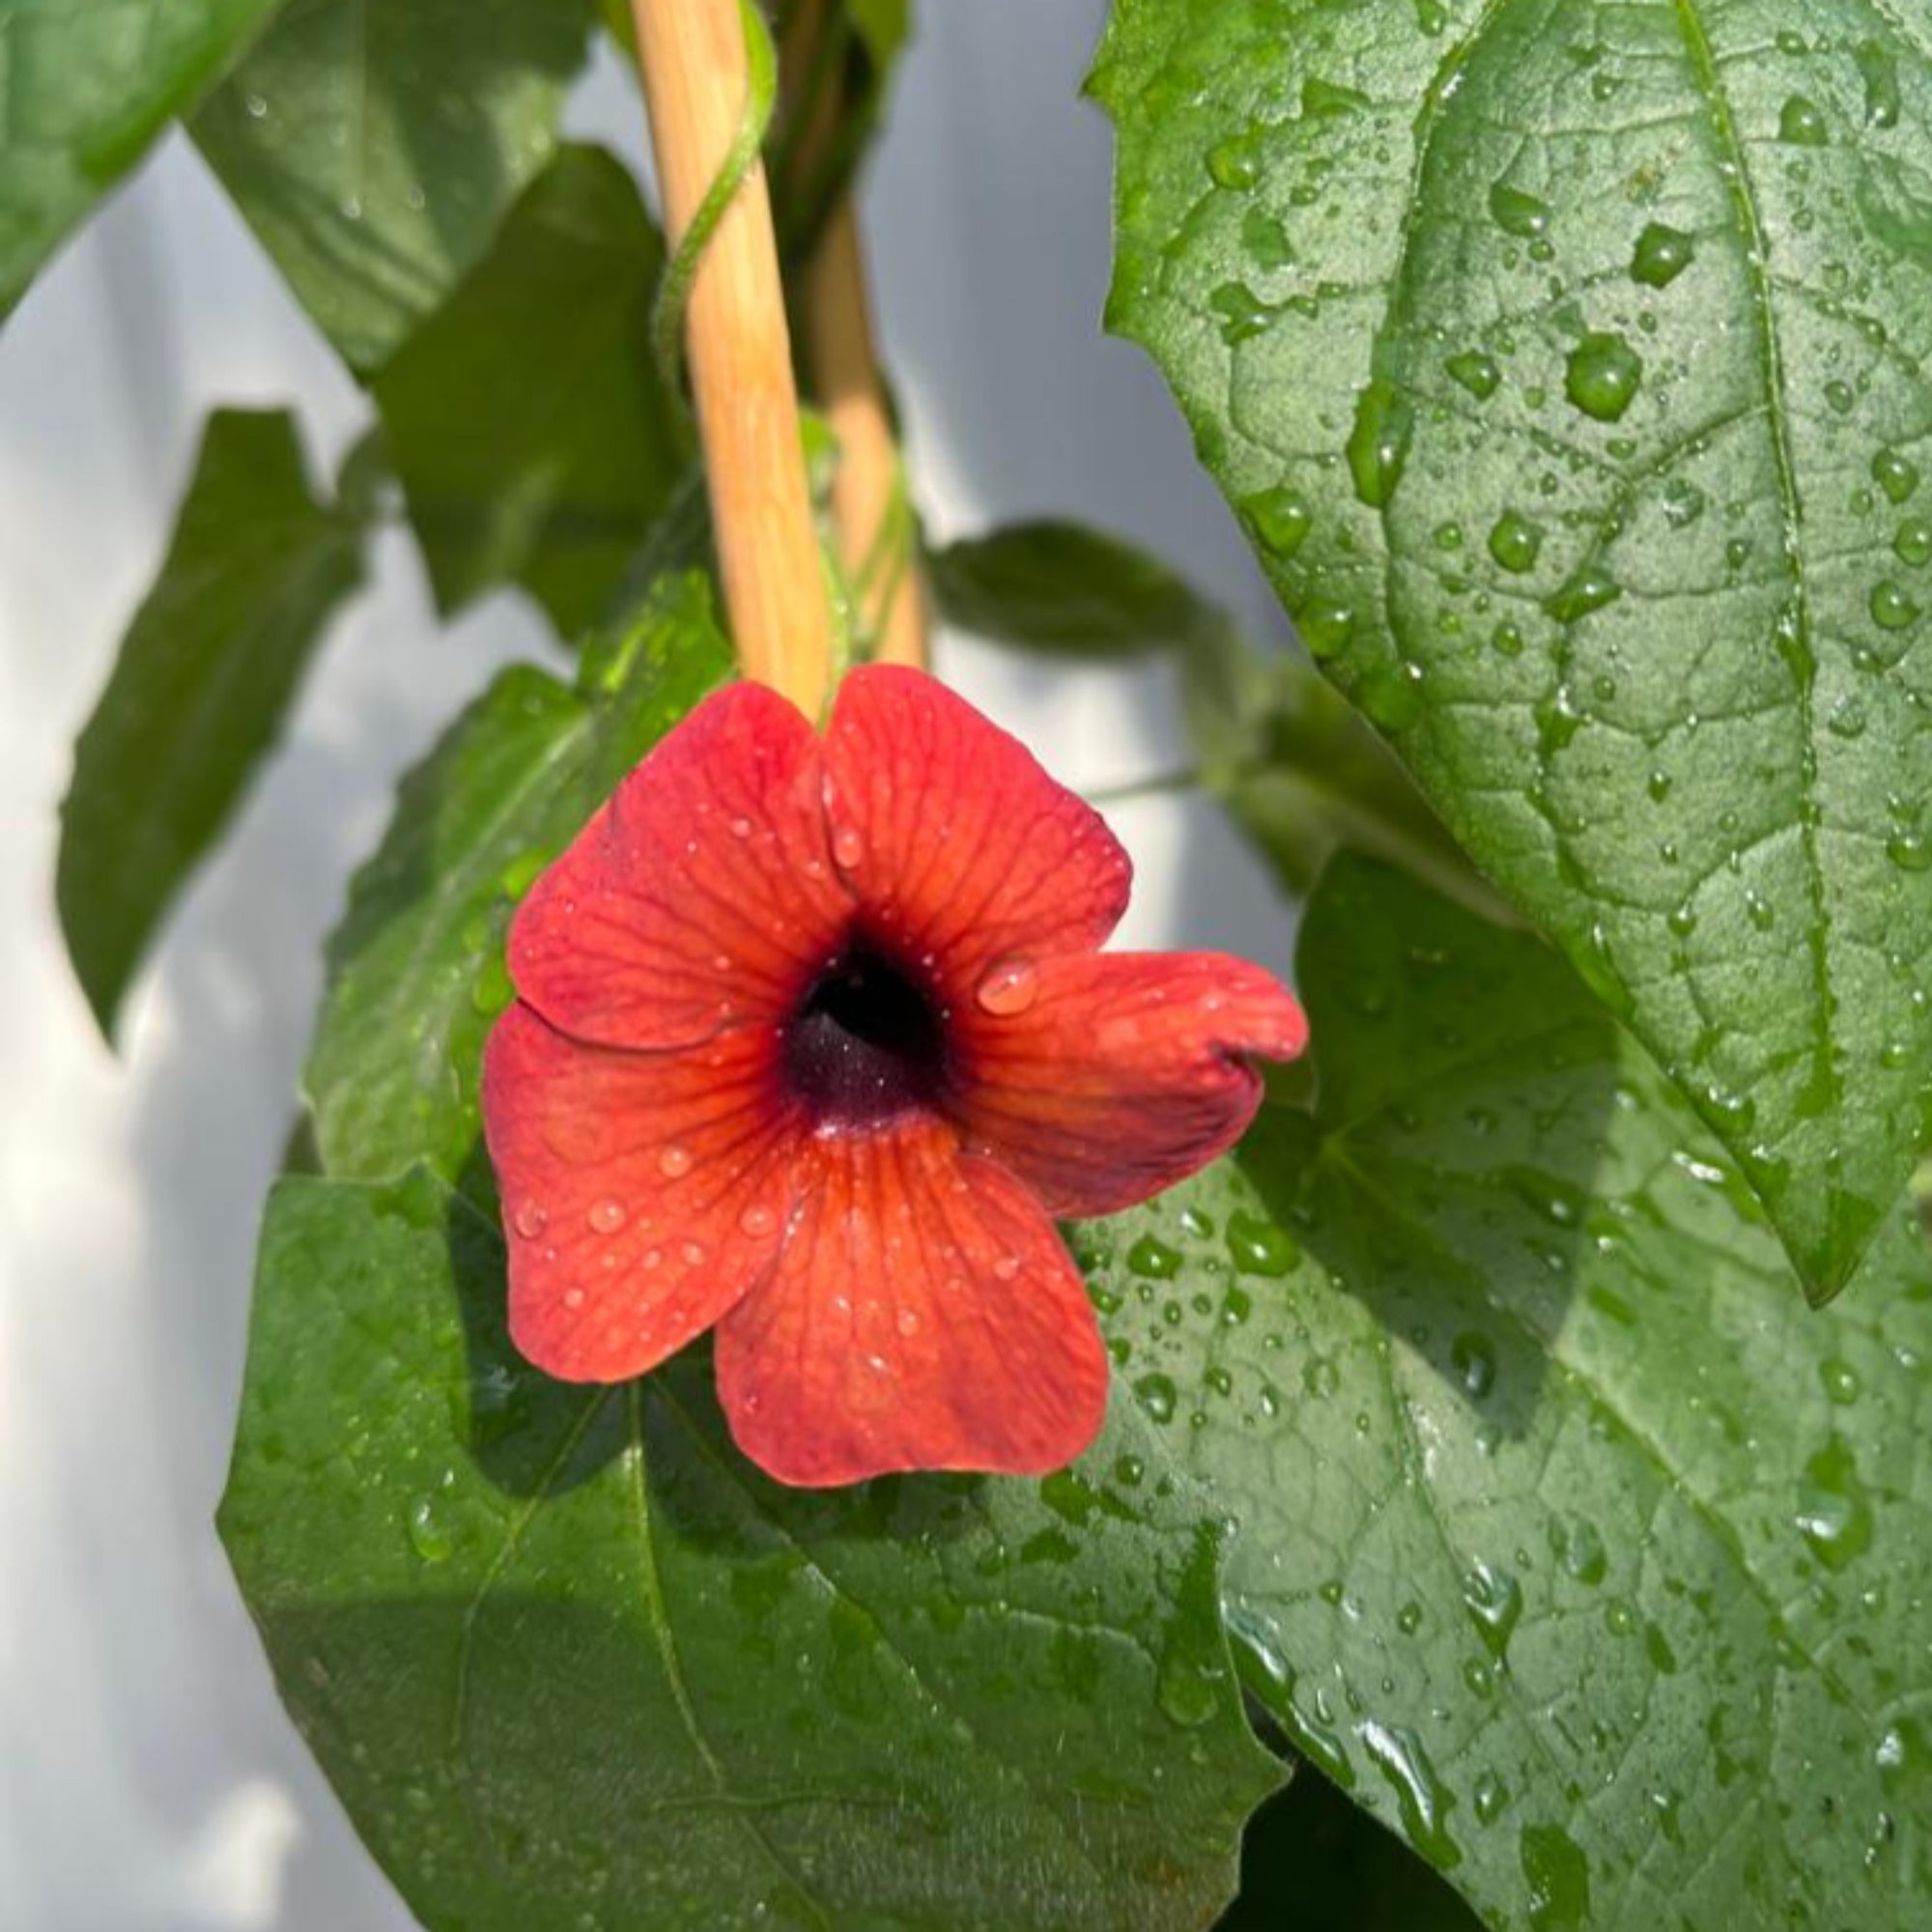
[632,0,833,719]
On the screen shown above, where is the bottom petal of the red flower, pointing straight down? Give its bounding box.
[717,1122,1107,1488]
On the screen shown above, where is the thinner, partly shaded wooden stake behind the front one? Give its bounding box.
[806,197,925,665]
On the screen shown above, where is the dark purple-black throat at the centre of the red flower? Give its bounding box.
[784,941,947,1130]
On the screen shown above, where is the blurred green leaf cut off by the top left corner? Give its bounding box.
[0,0,274,317]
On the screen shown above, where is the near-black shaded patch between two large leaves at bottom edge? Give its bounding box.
[1215,1766,1482,1932]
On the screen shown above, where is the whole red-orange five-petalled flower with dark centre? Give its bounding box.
[483,667,1306,1484]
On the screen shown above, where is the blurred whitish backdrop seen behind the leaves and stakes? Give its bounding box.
[0,0,1289,1932]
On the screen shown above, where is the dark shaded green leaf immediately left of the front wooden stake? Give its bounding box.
[373,147,682,634]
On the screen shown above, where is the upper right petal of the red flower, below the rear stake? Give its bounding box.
[825,665,1132,1001]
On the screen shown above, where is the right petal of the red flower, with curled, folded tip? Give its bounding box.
[954,952,1308,1215]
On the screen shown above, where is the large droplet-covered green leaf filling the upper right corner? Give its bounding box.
[1094,0,1932,1296]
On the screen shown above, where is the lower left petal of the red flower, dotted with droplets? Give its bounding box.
[483,1003,798,1381]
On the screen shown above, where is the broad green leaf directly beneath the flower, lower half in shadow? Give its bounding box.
[220,1175,1275,1932]
